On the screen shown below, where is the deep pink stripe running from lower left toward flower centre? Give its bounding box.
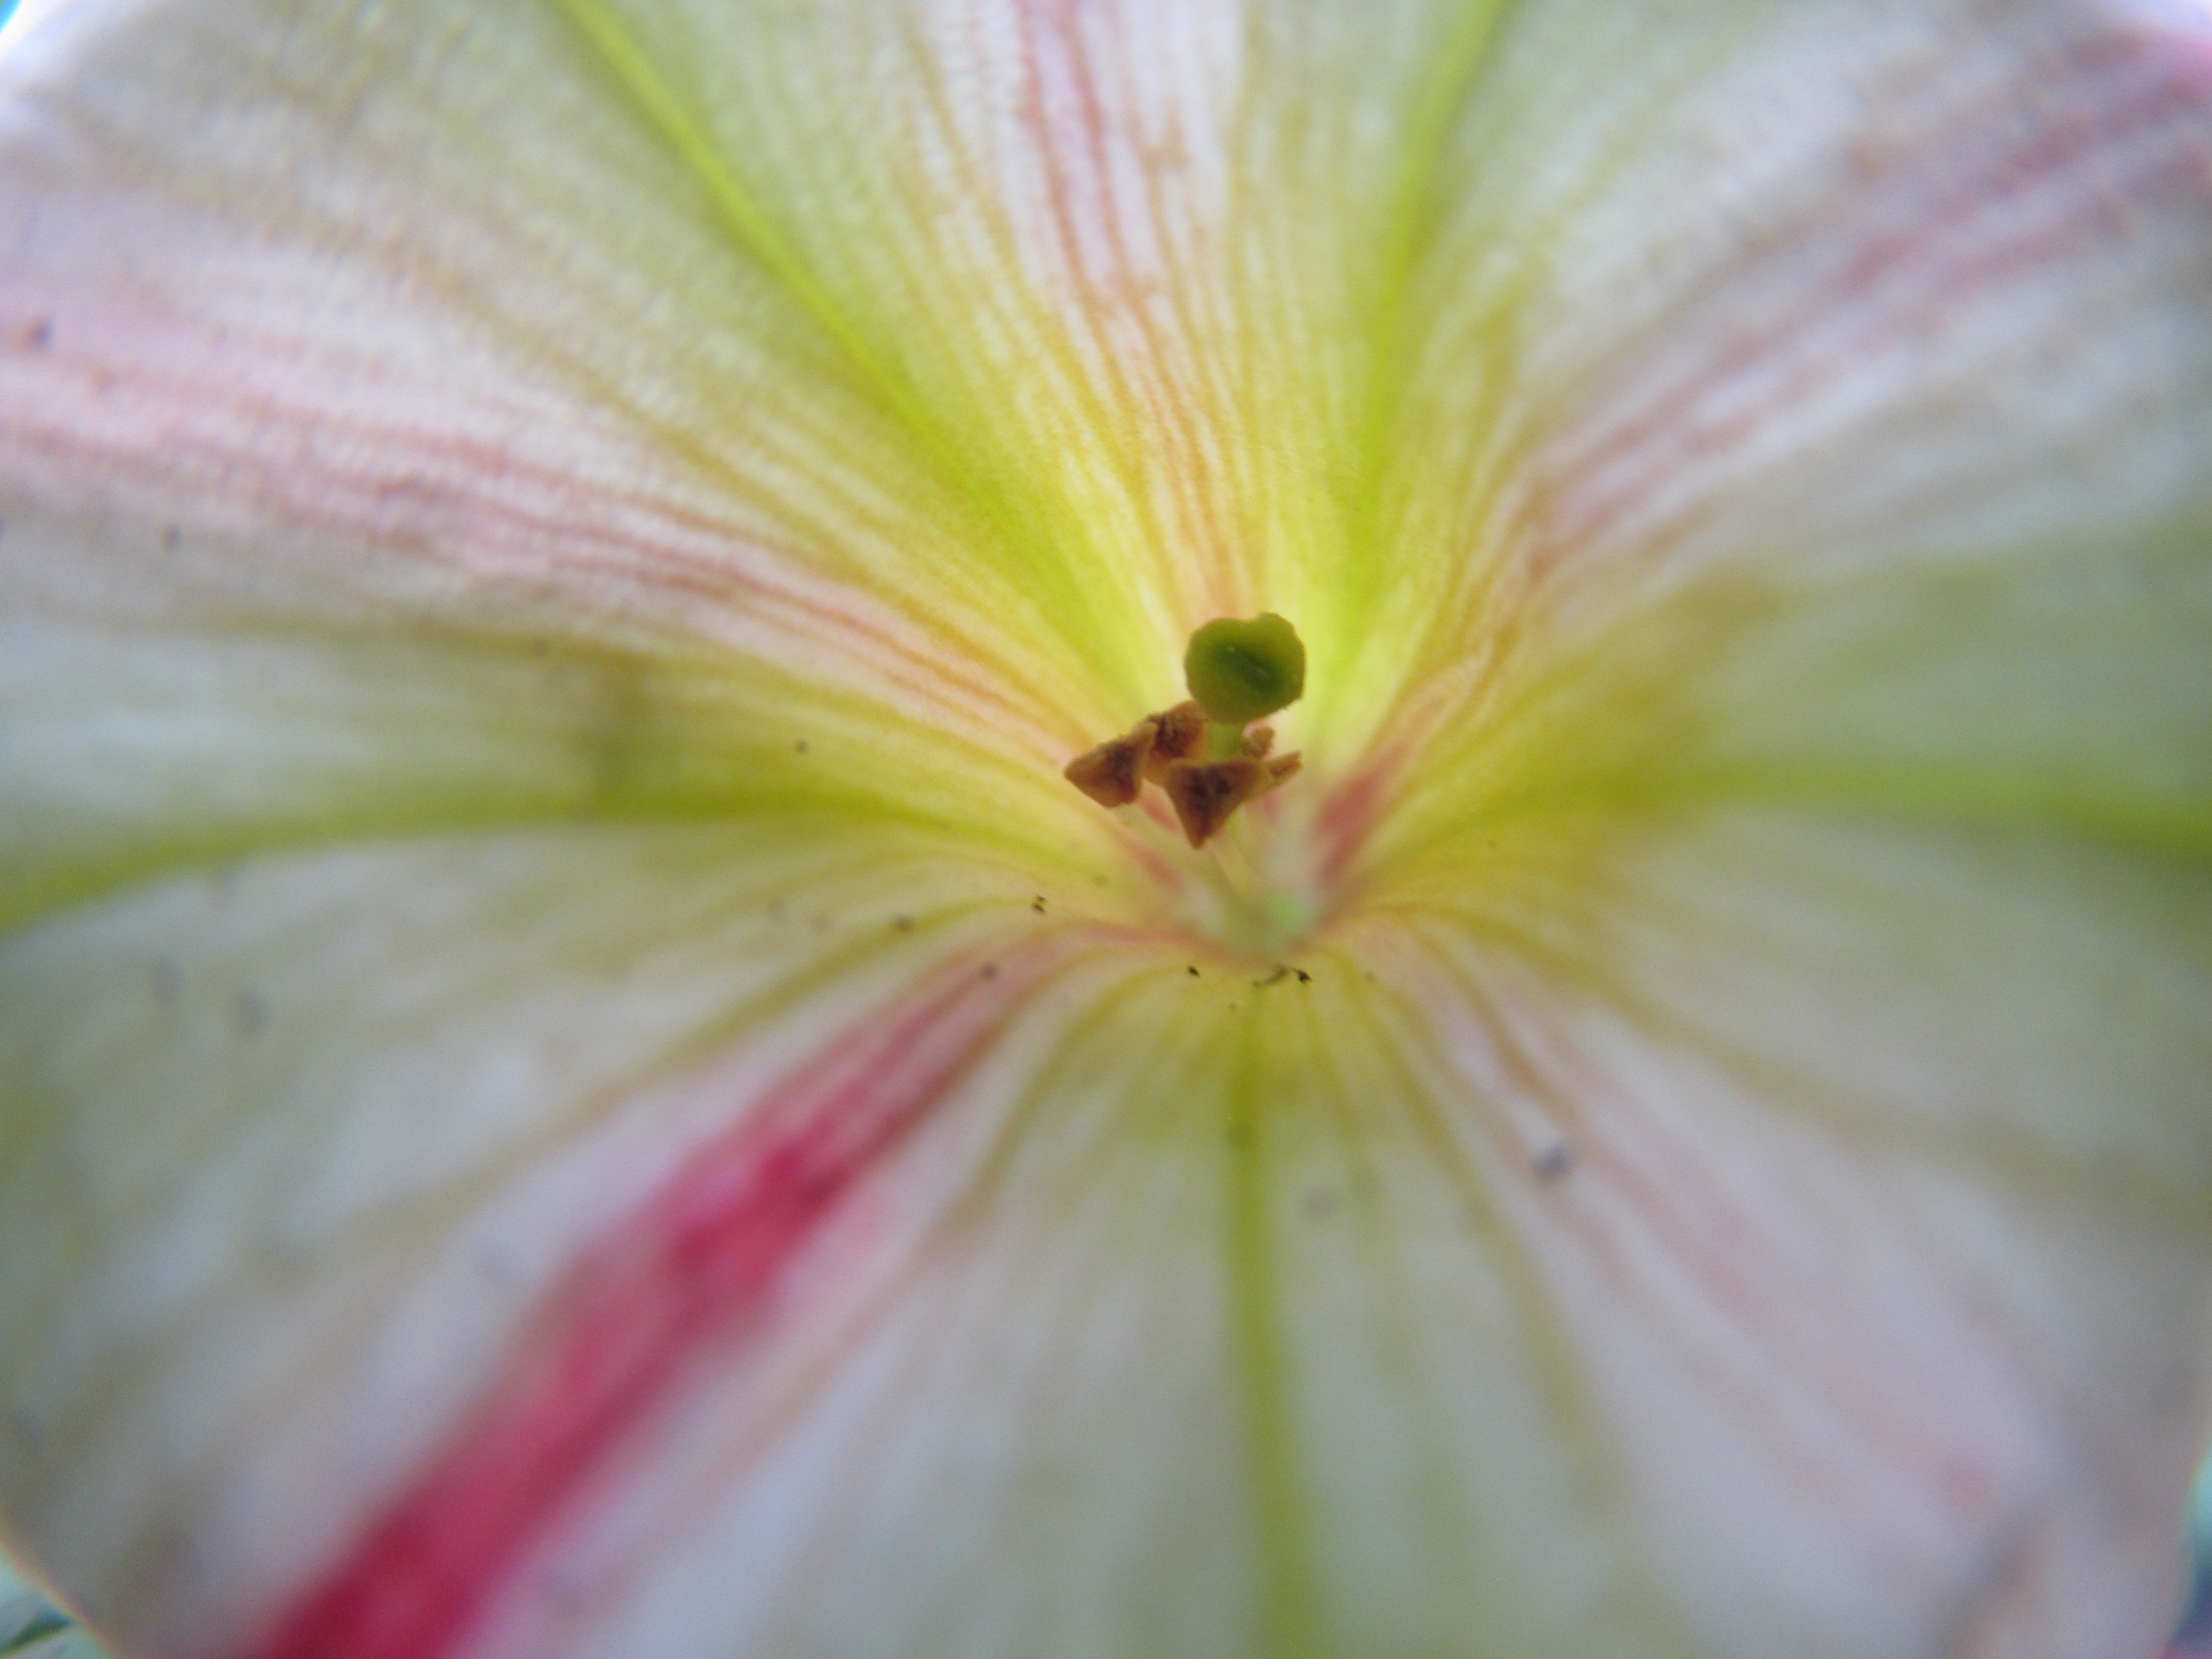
[248,953,1044,1659]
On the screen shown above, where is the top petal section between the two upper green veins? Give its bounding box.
[506,0,1504,721]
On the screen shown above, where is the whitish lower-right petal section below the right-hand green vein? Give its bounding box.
[1378,810,2212,1654]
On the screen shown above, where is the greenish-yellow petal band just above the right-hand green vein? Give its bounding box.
[1369,513,2212,889]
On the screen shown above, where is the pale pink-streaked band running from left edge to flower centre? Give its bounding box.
[0,261,1066,756]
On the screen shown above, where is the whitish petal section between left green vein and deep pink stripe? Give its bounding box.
[0,821,1097,1652]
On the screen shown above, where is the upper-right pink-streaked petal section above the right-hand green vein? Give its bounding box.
[1369,5,2212,832]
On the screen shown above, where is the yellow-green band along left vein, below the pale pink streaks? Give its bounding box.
[0,610,1101,935]
